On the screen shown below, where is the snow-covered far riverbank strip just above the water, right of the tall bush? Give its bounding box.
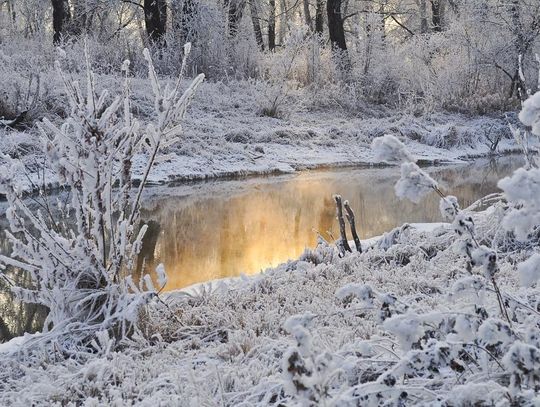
[132,107,518,183]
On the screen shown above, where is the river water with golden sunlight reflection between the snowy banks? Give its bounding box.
[139,160,519,290]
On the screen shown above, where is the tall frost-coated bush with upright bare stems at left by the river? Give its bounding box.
[0,44,204,357]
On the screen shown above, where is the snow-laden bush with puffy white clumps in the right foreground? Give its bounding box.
[286,124,540,406]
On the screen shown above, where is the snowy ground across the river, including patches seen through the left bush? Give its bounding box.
[0,77,516,187]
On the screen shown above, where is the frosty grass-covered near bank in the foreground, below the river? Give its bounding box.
[0,208,538,406]
